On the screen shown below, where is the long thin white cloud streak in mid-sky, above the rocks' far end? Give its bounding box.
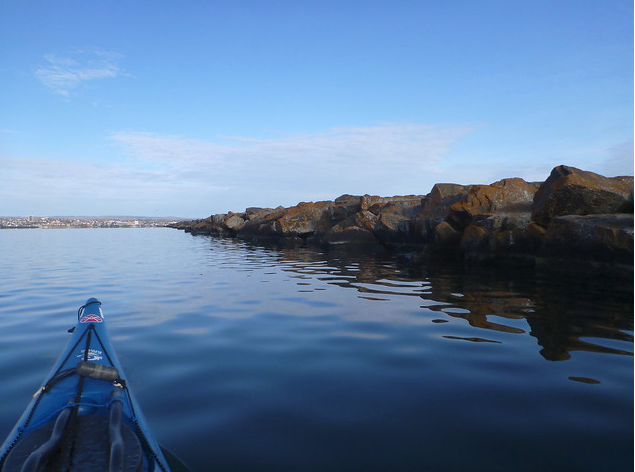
[111,123,472,174]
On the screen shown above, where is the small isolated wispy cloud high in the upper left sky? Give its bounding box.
[35,49,124,96]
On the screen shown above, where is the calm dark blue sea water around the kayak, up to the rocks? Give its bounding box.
[0,229,633,472]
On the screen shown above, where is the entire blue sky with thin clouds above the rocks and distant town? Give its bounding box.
[0,0,633,218]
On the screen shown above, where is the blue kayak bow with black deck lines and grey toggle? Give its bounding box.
[0,298,179,472]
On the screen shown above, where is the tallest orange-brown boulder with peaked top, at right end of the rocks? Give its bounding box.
[532,165,633,226]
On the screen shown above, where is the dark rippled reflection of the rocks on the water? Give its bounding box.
[210,240,633,361]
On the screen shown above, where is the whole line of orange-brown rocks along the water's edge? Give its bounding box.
[170,165,633,272]
